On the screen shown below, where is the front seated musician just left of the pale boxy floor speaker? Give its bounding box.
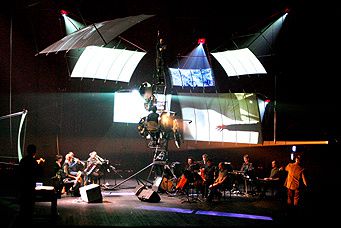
[63,152,85,196]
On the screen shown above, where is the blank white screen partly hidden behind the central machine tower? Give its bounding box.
[113,90,171,123]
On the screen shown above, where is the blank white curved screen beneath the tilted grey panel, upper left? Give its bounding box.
[71,46,146,82]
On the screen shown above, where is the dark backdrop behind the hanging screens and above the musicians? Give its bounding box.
[0,0,340,164]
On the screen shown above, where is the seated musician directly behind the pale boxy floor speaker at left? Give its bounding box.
[84,151,103,184]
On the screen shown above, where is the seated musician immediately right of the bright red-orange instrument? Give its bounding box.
[200,158,218,198]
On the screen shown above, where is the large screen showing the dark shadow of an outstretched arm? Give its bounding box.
[179,93,261,144]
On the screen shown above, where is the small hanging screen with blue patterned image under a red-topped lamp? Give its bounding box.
[169,68,215,87]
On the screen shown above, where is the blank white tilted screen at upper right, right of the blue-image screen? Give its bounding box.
[211,48,266,76]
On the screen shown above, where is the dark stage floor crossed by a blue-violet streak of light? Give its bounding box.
[0,179,318,227]
